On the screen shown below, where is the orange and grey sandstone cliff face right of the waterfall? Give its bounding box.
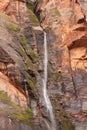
[37,0,87,130]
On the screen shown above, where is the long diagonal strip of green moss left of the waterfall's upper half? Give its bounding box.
[18,36,37,90]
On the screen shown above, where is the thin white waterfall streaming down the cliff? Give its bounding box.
[43,32,56,130]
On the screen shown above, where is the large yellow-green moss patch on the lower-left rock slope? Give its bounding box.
[0,91,33,125]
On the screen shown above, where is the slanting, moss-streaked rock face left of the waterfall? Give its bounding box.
[0,0,43,130]
